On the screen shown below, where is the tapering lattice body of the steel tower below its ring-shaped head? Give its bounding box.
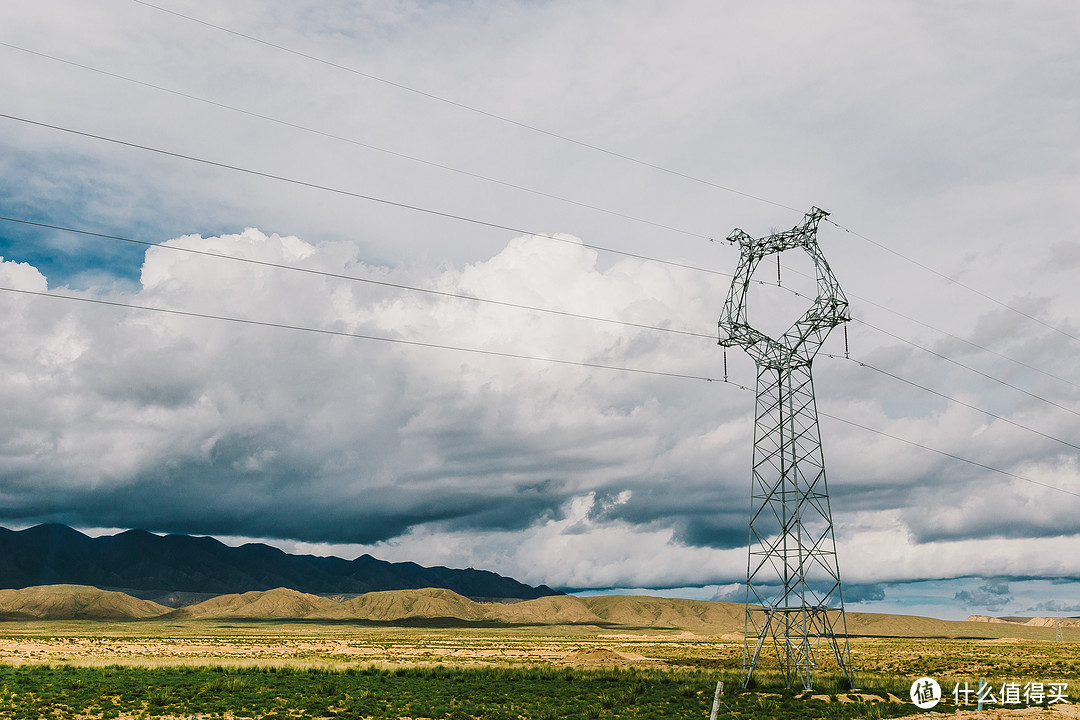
[743,362,853,690]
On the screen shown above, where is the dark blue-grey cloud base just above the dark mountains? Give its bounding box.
[5,446,574,543]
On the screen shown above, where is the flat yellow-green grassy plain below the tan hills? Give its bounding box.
[0,621,1080,720]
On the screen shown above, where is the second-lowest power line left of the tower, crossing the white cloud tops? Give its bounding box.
[0,216,716,340]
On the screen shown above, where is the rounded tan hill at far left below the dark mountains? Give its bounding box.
[0,585,170,620]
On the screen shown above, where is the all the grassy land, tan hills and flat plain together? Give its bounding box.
[0,589,1080,720]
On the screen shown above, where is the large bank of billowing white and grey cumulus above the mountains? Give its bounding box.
[0,223,1080,591]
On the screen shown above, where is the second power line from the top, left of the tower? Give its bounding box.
[0,42,715,242]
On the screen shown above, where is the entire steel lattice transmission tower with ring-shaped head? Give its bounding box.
[719,207,853,690]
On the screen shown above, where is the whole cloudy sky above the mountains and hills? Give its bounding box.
[0,0,1080,619]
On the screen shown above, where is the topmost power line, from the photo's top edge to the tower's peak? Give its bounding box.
[132,0,800,213]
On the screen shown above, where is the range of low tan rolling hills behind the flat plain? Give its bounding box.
[0,585,1075,640]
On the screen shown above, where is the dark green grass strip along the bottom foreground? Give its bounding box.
[0,665,915,720]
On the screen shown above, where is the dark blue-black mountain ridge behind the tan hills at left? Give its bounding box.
[0,525,563,604]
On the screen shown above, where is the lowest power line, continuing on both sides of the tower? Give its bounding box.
[0,287,1080,498]
